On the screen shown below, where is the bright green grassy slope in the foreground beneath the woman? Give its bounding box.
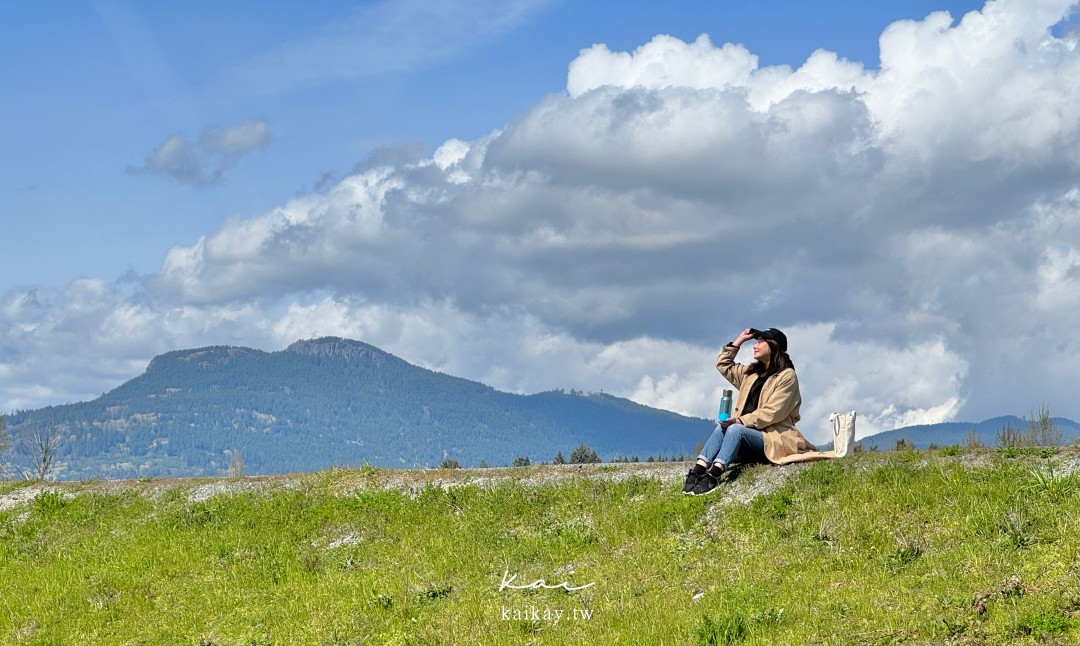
[0,448,1080,646]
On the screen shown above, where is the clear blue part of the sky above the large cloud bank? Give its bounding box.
[0,0,981,286]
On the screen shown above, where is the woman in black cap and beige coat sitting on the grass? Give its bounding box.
[683,327,828,496]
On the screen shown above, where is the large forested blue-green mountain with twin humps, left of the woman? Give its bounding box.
[6,337,713,480]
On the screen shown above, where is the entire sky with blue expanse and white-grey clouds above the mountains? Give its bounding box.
[0,0,1080,436]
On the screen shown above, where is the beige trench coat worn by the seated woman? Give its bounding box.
[716,344,835,465]
